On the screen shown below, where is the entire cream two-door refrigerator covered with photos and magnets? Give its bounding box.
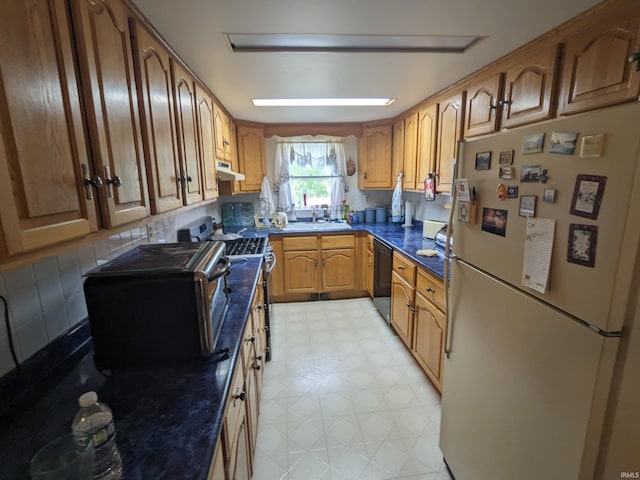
[440,103,640,480]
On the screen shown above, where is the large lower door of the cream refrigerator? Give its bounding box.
[440,261,618,480]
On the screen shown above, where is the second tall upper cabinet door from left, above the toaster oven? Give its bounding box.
[71,0,149,228]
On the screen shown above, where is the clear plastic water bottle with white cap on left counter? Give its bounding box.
[71,392,122,480]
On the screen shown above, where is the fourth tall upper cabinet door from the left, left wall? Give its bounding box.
[171,58,204,205]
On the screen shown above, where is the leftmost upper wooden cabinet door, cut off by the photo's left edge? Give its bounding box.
[0,0,98,256]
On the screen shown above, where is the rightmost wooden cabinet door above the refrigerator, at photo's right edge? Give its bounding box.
[558,7,640,115]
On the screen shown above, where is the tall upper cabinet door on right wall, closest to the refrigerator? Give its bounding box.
[436,93,464,192]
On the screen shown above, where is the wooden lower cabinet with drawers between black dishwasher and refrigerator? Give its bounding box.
[391,252,447,392]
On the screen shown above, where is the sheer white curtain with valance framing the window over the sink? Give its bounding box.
[274,135,349,212]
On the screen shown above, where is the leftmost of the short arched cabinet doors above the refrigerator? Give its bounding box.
[464,73,504,138]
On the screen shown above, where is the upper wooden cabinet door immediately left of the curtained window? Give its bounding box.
[237,125,266,193]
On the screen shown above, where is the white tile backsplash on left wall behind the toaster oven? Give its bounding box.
[0,203,220,376]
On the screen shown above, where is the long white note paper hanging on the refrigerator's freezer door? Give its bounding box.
[521,218,556,293]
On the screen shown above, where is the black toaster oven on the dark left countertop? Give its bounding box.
[84,242,230,370]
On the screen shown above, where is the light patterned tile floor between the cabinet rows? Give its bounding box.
[253,298,451,480]
